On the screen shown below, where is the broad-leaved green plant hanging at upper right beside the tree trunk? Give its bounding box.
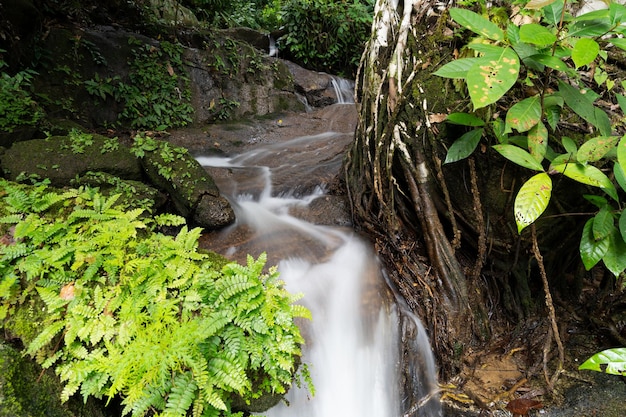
[435,0,626,276]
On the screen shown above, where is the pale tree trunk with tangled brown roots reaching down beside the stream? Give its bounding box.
[345,0,476,375]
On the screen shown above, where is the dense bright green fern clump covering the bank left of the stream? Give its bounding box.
[0,180,309,416]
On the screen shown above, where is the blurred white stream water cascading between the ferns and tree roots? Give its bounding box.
[198,137,442,417]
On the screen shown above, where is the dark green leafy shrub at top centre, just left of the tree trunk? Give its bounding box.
[280,0,374,78]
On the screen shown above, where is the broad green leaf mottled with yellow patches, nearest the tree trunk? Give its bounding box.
[467,48,520,109]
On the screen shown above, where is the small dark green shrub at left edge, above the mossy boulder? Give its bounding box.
[0,50,44,132]
